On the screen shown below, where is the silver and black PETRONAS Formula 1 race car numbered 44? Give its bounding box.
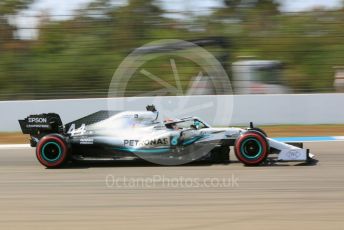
[19,105,313,168]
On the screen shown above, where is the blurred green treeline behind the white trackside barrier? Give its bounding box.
[0,0,344,99]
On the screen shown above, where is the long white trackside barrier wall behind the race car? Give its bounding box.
[0,94,344,132]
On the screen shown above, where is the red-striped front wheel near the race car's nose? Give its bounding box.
[234,130,270,166]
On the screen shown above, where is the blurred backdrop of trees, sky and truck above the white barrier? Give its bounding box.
[0,0,344,100]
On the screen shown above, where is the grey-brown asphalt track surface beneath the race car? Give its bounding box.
[0,142,344,230]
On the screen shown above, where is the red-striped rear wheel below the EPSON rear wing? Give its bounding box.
[36,135,68,168]
